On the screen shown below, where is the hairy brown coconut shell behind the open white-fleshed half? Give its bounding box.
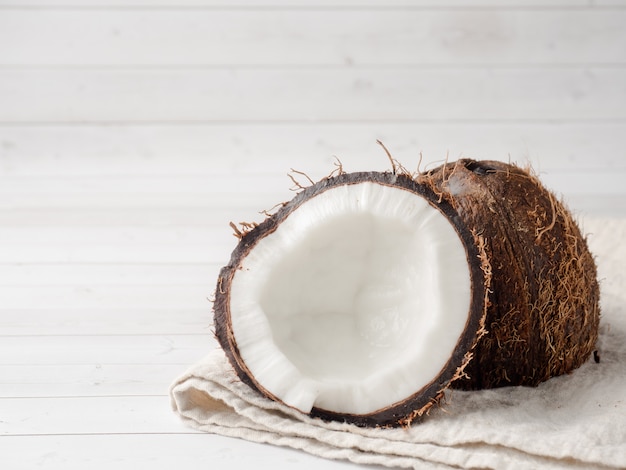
[421,160,600,389]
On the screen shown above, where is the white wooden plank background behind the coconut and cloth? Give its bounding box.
[0,0,626,469]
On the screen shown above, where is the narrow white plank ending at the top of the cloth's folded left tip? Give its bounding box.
[0,364,184,400]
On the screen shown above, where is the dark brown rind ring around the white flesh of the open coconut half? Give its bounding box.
[213,172,491,427]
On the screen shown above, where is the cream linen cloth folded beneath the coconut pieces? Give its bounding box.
[170,219,626,469]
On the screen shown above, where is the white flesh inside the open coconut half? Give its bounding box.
[230,182,471,415]
